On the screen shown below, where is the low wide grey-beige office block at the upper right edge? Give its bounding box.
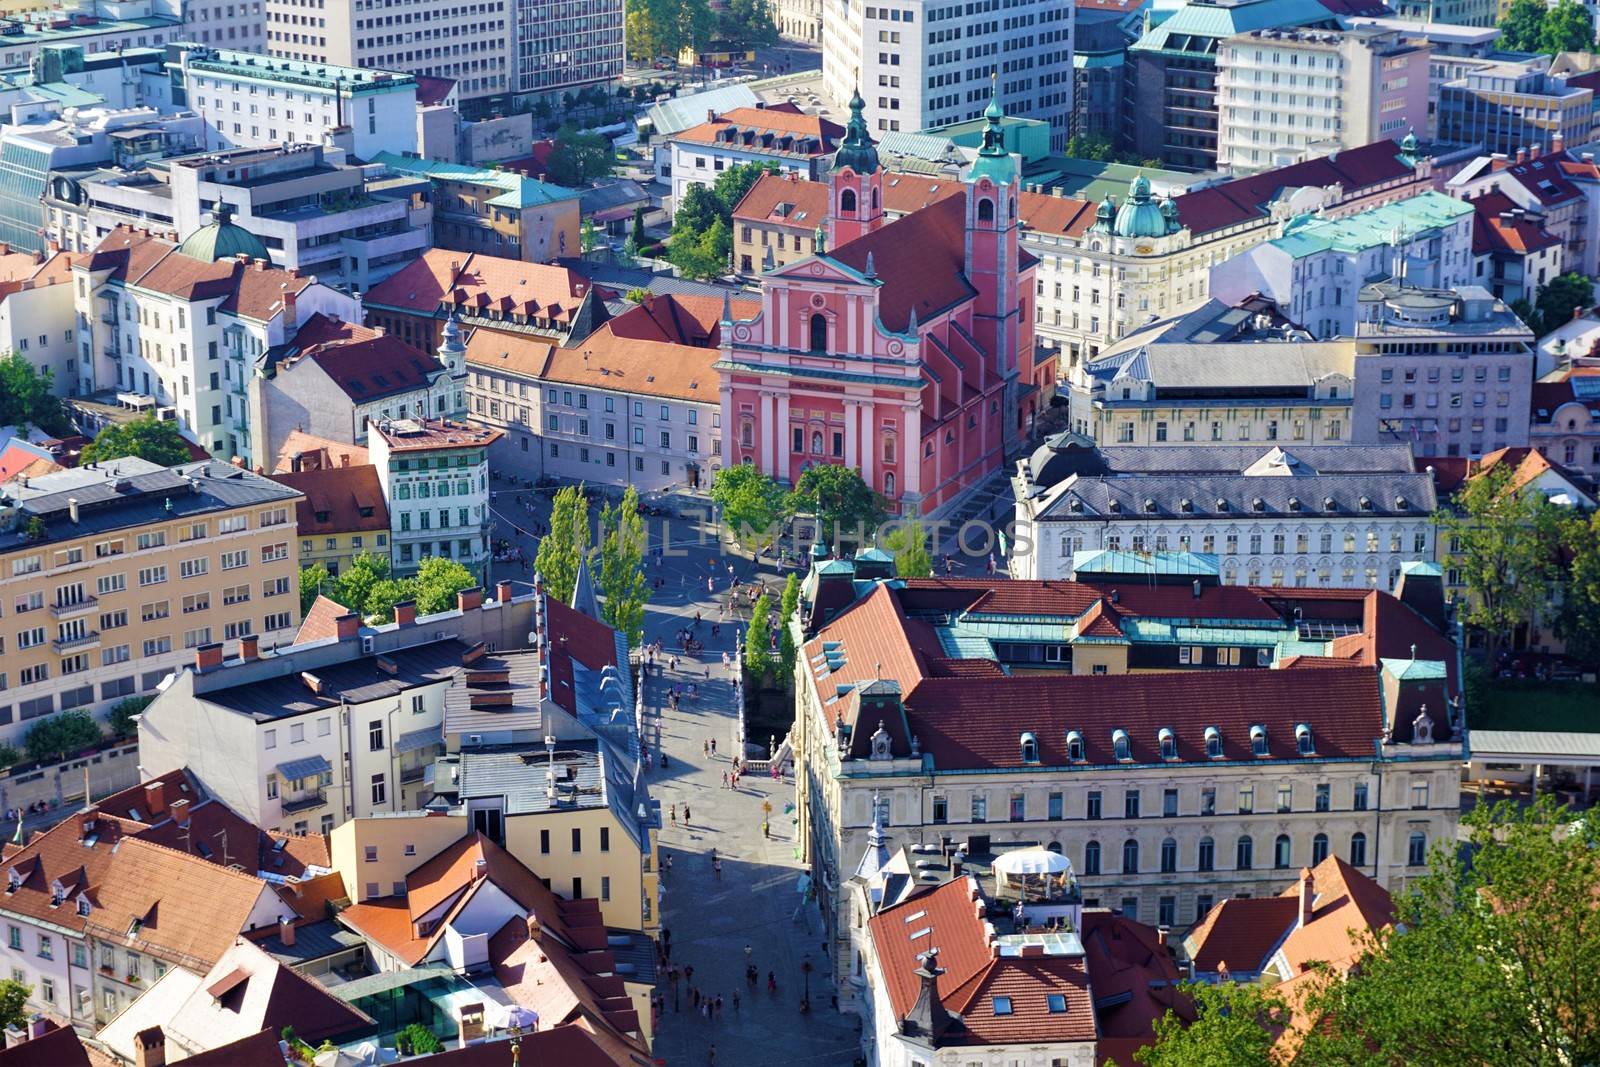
[1437,56,1594,157]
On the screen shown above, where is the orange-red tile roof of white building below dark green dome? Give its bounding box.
[85,226,312,322]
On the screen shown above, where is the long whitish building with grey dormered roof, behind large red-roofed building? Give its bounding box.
[1011,435,1437,590]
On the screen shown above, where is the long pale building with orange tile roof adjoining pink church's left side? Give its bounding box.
[467,290,736,491]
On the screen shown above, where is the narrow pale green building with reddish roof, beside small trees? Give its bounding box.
[366,418,501,577]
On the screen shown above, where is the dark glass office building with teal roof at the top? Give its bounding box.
[1123,0,1339,171]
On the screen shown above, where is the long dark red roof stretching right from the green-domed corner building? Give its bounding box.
[1173,141,1416,235]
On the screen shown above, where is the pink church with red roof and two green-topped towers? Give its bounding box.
[717,91,1056,517]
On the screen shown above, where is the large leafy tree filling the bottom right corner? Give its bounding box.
[1296,797,1600,1067]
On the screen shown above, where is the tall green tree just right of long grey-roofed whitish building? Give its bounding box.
[1440,466,1555,662]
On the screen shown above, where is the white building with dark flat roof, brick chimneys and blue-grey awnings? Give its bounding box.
[139,582,533,832]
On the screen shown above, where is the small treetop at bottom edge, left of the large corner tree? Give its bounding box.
[1133,982,1285,1067]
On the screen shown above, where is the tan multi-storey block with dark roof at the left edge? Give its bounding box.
[0,458,299,742]
